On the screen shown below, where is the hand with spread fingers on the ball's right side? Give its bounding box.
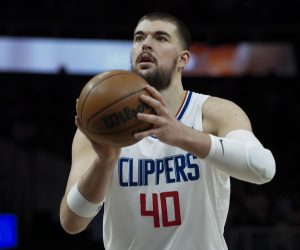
[134,85,184,146]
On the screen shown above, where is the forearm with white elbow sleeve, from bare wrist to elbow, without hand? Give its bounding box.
[176,127,275,184]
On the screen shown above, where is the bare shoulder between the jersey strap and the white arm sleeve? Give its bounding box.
[202,96,251,136]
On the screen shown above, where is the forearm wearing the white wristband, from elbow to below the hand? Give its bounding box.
[60,158,113,234]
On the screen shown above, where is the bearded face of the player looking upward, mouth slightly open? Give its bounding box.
[131,20,180,90]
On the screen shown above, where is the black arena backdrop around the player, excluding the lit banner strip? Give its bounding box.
[0,0,300,249]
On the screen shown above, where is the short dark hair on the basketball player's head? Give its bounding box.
[138,12,191,50]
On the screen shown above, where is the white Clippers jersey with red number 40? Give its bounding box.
[103,91,230,250]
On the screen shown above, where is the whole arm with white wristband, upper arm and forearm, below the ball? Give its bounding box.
[60,129,119,234]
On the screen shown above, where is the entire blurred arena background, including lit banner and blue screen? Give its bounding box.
[0,0,300,250]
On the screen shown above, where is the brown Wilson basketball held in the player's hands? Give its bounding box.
[77,70,154,147]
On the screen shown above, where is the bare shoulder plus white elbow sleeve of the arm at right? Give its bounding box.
[198,97,276,184]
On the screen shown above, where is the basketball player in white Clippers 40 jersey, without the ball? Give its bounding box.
[60,13,275,250]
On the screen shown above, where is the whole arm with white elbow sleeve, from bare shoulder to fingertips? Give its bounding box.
[135,86,275,184]
